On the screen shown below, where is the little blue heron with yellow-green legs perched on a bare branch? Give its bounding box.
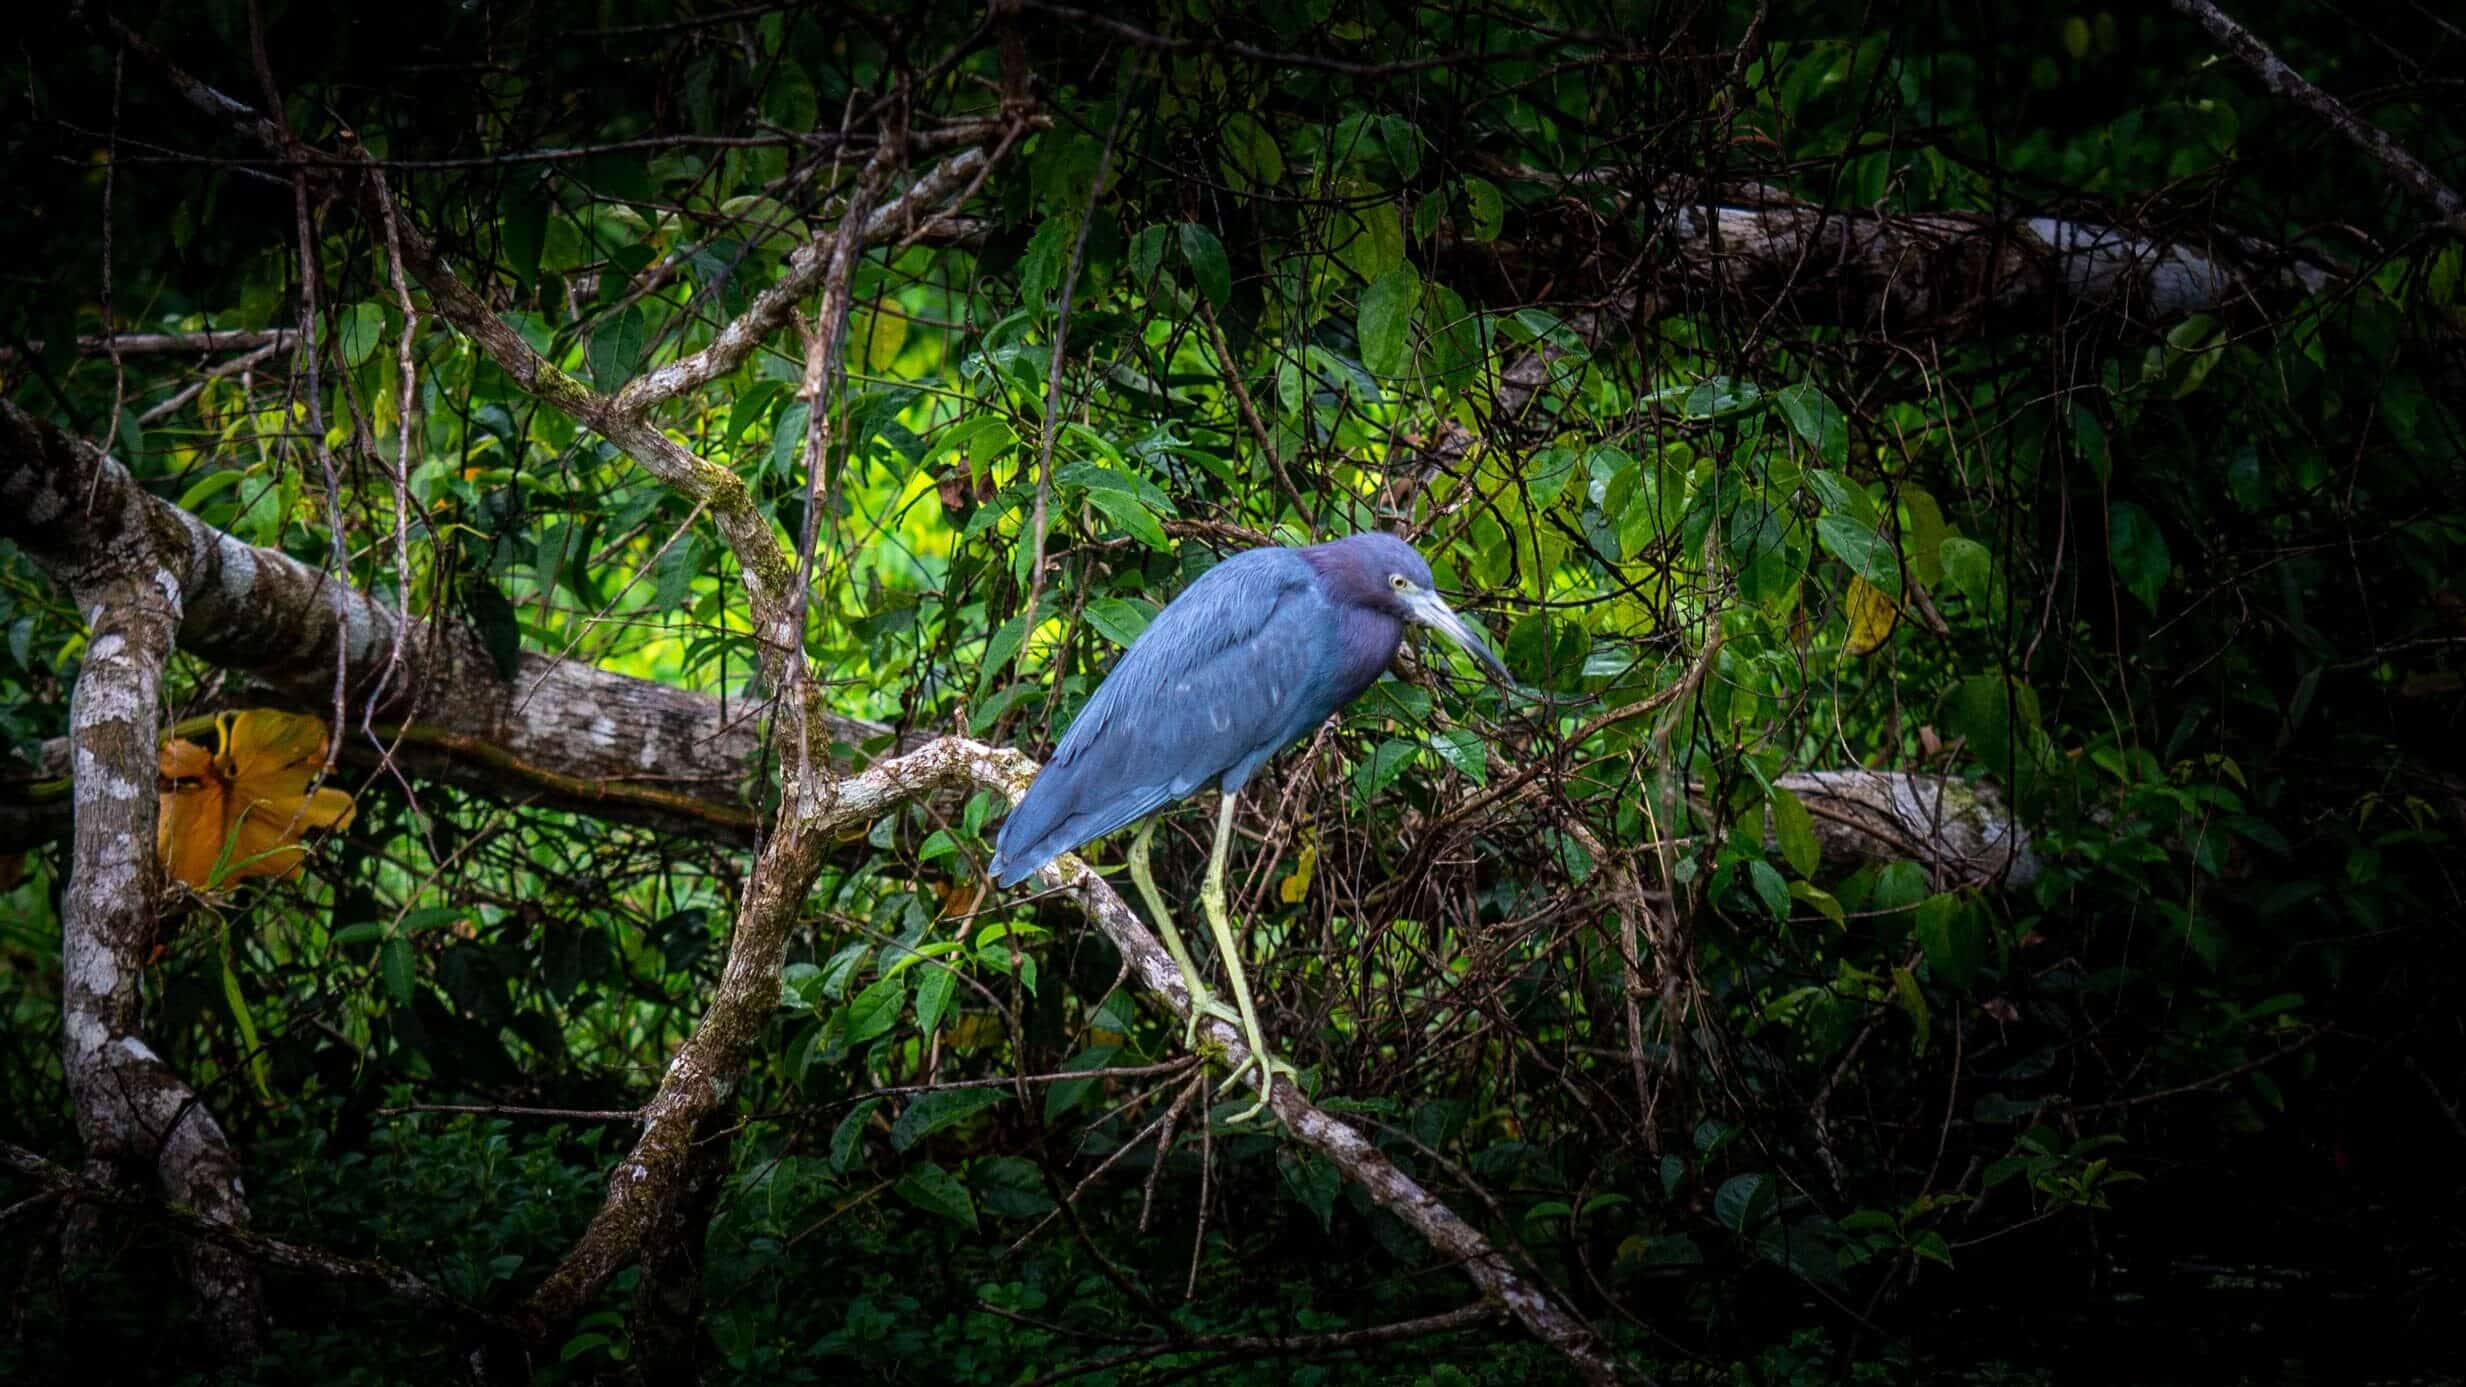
[989,533,1507,1120]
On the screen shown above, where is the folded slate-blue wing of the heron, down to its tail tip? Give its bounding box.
[991,550,1332,886]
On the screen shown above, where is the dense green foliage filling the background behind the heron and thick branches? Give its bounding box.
[0,0,2466,1382]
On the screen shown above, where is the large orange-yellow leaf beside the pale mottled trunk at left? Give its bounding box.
[155,708,353,891]
